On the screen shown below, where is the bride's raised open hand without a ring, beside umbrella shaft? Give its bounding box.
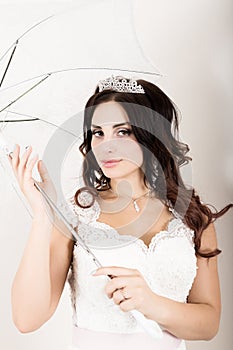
[9,145,56,217]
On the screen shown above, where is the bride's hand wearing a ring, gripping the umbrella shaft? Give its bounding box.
[93,266,156,316]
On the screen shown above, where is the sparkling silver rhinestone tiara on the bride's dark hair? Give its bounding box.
[98,75,145,94]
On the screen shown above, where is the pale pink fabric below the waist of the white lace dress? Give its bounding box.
[70,326,186,350]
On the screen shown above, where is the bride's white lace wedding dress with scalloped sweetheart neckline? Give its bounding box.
[62,191,197,350]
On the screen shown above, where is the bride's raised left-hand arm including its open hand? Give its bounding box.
[9,145,73,332]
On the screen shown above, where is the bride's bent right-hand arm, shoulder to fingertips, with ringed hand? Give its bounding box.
[95,224,221,340]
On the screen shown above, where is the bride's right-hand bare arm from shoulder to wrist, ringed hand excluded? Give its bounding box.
[148,224,221,340]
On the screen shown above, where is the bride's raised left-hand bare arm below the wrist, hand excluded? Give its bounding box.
[12,216,73,332]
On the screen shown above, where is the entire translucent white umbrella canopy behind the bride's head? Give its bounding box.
[0,0,160,216]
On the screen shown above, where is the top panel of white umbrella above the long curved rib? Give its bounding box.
[0,0,158,87]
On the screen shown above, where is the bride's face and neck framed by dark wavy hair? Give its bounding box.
[91,101,148,197]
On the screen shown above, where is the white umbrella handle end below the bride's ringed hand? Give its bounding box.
[130,310,163,339]
